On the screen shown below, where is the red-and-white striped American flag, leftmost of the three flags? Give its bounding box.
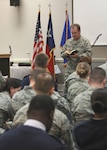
[32,11,44,69]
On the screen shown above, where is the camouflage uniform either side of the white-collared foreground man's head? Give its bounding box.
[13,103,75,150]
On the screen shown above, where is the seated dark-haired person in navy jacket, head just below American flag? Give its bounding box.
[22,53,48,88]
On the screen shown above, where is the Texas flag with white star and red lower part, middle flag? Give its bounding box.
[46,13,55,75]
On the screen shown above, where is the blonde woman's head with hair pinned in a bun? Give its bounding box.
[76,62,90,78]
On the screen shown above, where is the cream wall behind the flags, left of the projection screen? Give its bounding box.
[0,0,72,62]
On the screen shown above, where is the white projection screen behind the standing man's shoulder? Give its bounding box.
[74,0,107,45]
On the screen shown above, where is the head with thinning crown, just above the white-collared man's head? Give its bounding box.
[35,72,54,93]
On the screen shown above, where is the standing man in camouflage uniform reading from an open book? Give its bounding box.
[61,24,92,79]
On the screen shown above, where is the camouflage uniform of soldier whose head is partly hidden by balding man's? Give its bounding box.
[12,86,70,122]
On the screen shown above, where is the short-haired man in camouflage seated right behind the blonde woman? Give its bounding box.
[72,67,106,124]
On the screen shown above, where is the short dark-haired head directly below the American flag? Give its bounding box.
[35,52,48,68]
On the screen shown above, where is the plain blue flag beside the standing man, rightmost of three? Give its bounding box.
[60,10,71,63]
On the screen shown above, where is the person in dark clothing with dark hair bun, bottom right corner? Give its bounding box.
[74,88,107,150]
